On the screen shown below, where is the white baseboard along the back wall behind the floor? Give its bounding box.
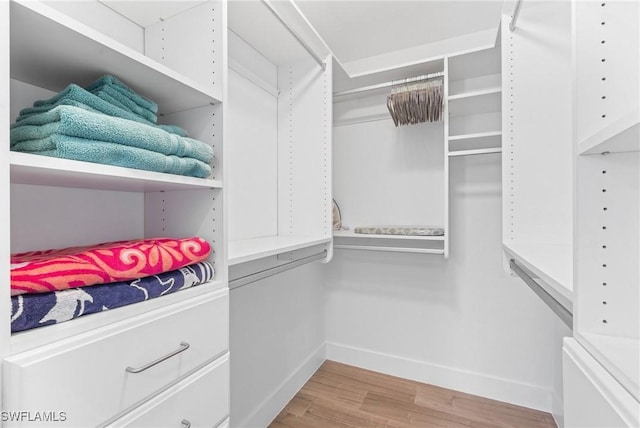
[326,343,552,412]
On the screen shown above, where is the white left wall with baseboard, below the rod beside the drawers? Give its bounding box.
[230,263,326,428]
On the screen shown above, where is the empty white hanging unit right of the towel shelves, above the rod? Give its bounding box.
[227,2,332,279]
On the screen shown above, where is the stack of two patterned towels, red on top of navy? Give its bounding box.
[11,237,214,332]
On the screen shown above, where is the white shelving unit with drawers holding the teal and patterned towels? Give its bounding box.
[0,0,229,426]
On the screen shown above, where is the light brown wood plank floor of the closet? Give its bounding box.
[270,361,556,428]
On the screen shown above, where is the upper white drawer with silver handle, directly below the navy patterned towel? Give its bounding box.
[3,289,229,427]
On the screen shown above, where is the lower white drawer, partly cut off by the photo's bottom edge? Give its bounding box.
[107,354,230,428]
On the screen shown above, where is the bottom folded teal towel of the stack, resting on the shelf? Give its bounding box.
[35,134,211,178]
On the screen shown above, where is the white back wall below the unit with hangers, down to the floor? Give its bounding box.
[326,149,560,411]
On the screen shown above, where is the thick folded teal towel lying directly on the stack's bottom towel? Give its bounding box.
[10,105,213,163]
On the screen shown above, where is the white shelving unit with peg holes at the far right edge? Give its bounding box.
[565,1,640,426]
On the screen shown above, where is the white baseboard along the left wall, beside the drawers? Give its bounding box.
[231,343,326,428]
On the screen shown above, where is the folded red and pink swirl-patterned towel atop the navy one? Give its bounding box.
[11,237,211,296]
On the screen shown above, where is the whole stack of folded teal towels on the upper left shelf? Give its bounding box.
[10,76,213,178]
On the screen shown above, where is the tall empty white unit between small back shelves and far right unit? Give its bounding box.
[501,2,574,319]
